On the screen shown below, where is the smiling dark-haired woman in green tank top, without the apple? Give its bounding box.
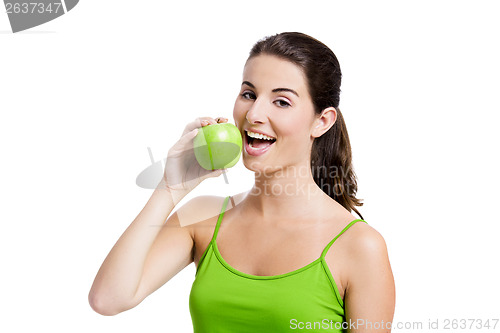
[89,33,395,333]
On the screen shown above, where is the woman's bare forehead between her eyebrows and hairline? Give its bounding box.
[243,55,307,95]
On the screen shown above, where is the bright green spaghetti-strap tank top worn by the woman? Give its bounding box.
[189,196,366,333]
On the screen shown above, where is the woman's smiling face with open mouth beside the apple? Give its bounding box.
[233,55,315,171]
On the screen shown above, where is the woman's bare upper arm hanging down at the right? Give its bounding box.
[345,225,395,333]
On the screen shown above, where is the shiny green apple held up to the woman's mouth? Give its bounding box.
[193,123,243,170]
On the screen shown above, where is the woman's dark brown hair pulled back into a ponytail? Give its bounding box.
[248,32,363,218]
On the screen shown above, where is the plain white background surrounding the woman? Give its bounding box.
[0,0,500,333]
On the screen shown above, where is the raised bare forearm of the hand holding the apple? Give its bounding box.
[89,186,188,313]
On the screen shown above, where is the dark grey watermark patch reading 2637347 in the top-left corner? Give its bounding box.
[4,0,79,33]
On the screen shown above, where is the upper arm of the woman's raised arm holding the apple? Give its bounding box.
[135,196,221,304]
